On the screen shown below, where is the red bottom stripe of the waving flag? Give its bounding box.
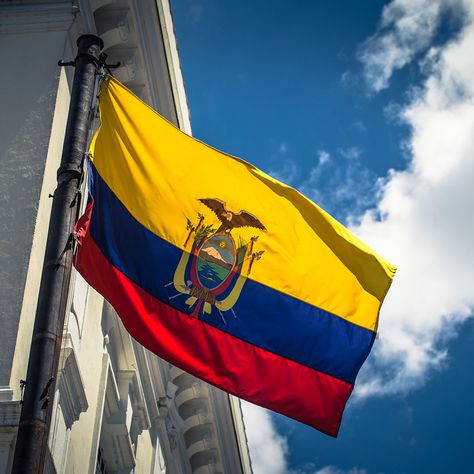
[76,233,353,436]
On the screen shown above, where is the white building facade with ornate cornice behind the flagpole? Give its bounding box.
[0,0,251,474]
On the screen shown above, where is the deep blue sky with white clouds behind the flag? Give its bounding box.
[171,0,474,474]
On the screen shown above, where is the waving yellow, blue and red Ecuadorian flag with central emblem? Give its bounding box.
[75,78,395,436]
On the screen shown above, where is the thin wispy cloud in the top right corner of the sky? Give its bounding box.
[359,0,470,92]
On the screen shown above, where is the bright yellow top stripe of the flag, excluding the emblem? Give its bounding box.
[91,79,395,330]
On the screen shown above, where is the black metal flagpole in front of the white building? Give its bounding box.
[12,35,104,473]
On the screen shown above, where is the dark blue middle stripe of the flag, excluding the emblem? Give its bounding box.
[90,161,375,384]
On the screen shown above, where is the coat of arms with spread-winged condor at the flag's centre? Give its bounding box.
[169,198,266,323]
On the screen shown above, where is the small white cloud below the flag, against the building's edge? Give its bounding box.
[241,400,288,474]
